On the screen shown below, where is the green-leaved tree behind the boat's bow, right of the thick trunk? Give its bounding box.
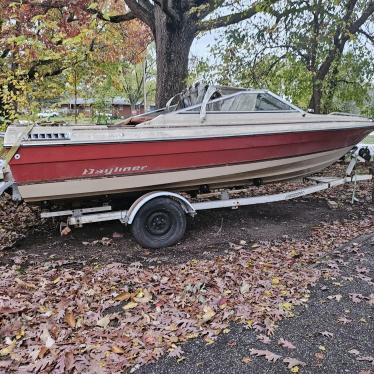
[213,0,374,113]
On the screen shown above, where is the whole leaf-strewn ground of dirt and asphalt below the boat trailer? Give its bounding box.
[0,165,374,374]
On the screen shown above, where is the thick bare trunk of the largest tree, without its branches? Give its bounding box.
[154,7,196,108]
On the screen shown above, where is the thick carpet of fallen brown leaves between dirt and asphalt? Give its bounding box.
[0,216,374,373]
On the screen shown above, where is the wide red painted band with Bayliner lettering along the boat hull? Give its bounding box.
[10,129,371,184]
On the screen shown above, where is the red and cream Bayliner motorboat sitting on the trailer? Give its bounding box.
[3,85,374,202]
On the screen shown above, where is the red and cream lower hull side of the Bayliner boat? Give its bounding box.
[6,126,372,201]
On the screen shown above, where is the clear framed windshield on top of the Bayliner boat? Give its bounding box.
[186,92,296,113]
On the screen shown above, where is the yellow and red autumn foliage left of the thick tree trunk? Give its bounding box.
[0,0,150,122]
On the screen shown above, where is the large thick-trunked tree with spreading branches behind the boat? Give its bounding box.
[24,0,279,107]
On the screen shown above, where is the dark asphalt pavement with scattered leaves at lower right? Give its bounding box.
[137,234,374,374]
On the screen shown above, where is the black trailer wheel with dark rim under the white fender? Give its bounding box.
[131,197,186,248]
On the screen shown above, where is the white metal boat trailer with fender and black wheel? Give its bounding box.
[36,156,374,248]
